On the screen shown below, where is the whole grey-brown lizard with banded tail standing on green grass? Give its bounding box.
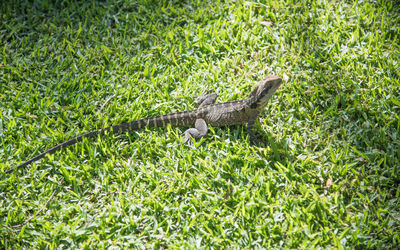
[5,76,282,173]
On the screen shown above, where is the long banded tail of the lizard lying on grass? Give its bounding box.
[5,111,195,173]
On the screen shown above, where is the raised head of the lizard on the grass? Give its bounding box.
[248,76,282,110]
